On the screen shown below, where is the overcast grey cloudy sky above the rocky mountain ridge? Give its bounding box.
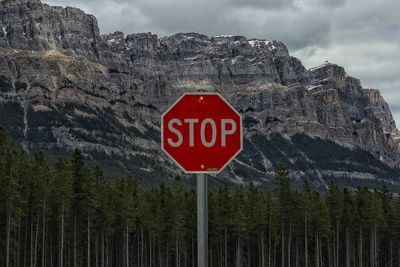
[47,0,400,126]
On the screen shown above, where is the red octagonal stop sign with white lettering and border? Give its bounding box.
[161,93,243,173]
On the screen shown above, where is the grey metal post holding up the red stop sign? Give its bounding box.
[197,173,208,267]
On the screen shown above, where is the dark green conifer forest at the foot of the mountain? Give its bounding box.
[0,130,400,267]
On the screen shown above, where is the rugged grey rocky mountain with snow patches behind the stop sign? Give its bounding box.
[0,0,400,191]
